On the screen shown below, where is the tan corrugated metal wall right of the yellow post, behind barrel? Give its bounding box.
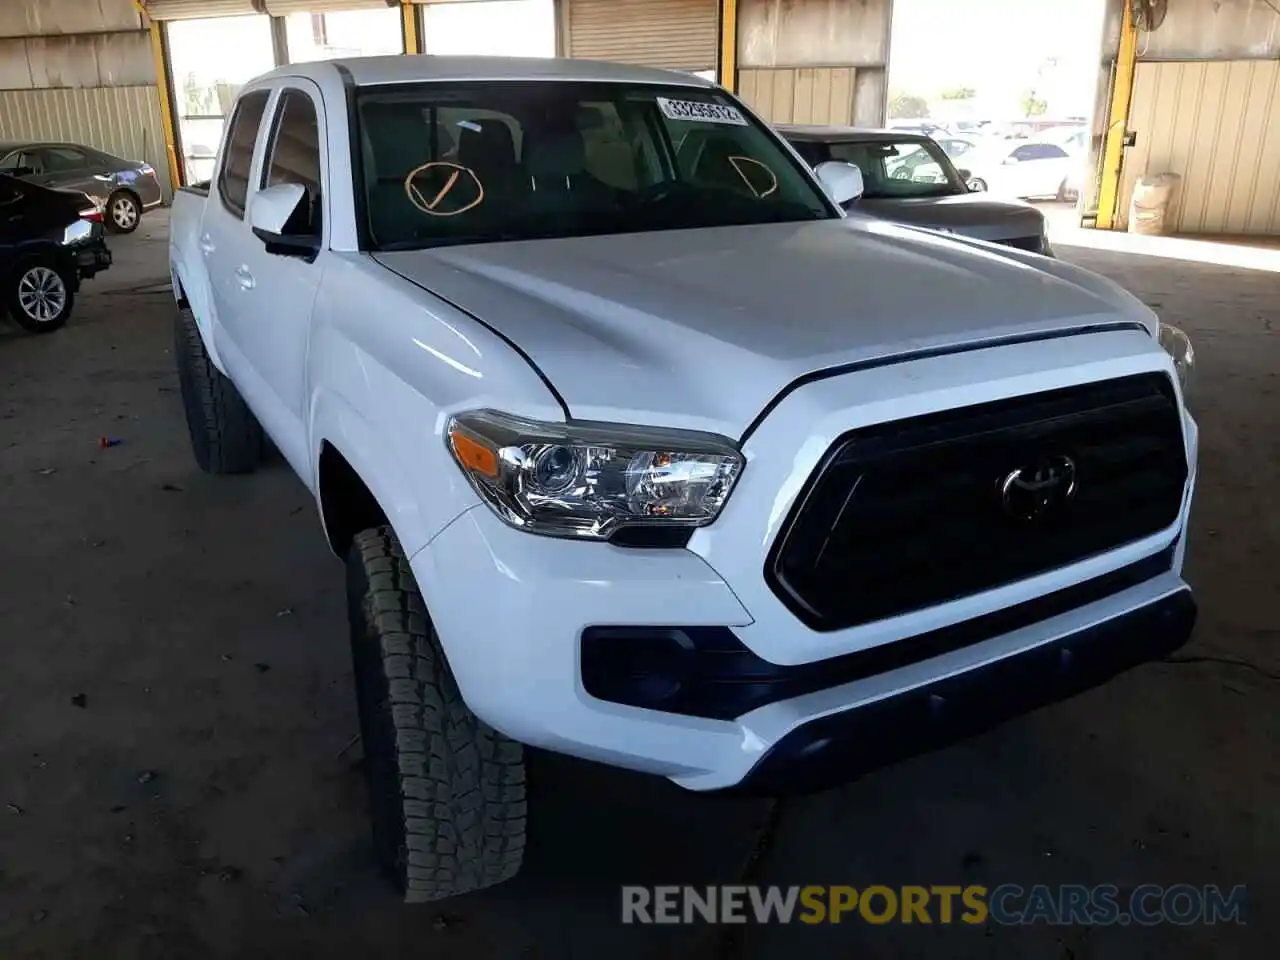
[1119,60,1280,236]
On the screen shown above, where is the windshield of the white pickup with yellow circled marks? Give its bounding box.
[356,82,836,250]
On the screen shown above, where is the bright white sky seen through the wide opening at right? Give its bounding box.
[890,0,1103,118]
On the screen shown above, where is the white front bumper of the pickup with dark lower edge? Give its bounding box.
[412,496,1193,792]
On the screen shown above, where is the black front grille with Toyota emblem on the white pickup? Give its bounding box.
[765,374,1187,630]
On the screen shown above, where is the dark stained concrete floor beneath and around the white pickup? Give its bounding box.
[0,215,1280,960]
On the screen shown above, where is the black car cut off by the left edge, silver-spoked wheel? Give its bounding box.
[0,174,111,333]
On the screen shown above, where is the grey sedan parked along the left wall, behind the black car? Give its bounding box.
[0,142,164,233]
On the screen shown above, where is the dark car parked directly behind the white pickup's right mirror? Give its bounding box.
[778,125,1052,256]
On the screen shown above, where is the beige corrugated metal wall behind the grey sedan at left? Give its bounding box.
[0,86,172,196]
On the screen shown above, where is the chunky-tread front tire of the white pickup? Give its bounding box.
[347,526,527,902]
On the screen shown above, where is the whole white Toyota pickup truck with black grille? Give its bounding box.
[170,56,1197,900]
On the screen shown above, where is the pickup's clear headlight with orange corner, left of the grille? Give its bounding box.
[445,410,744,540]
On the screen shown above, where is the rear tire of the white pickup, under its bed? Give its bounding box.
[173,307,264,474]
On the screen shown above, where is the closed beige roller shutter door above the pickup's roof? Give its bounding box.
[563,0,718,70]
